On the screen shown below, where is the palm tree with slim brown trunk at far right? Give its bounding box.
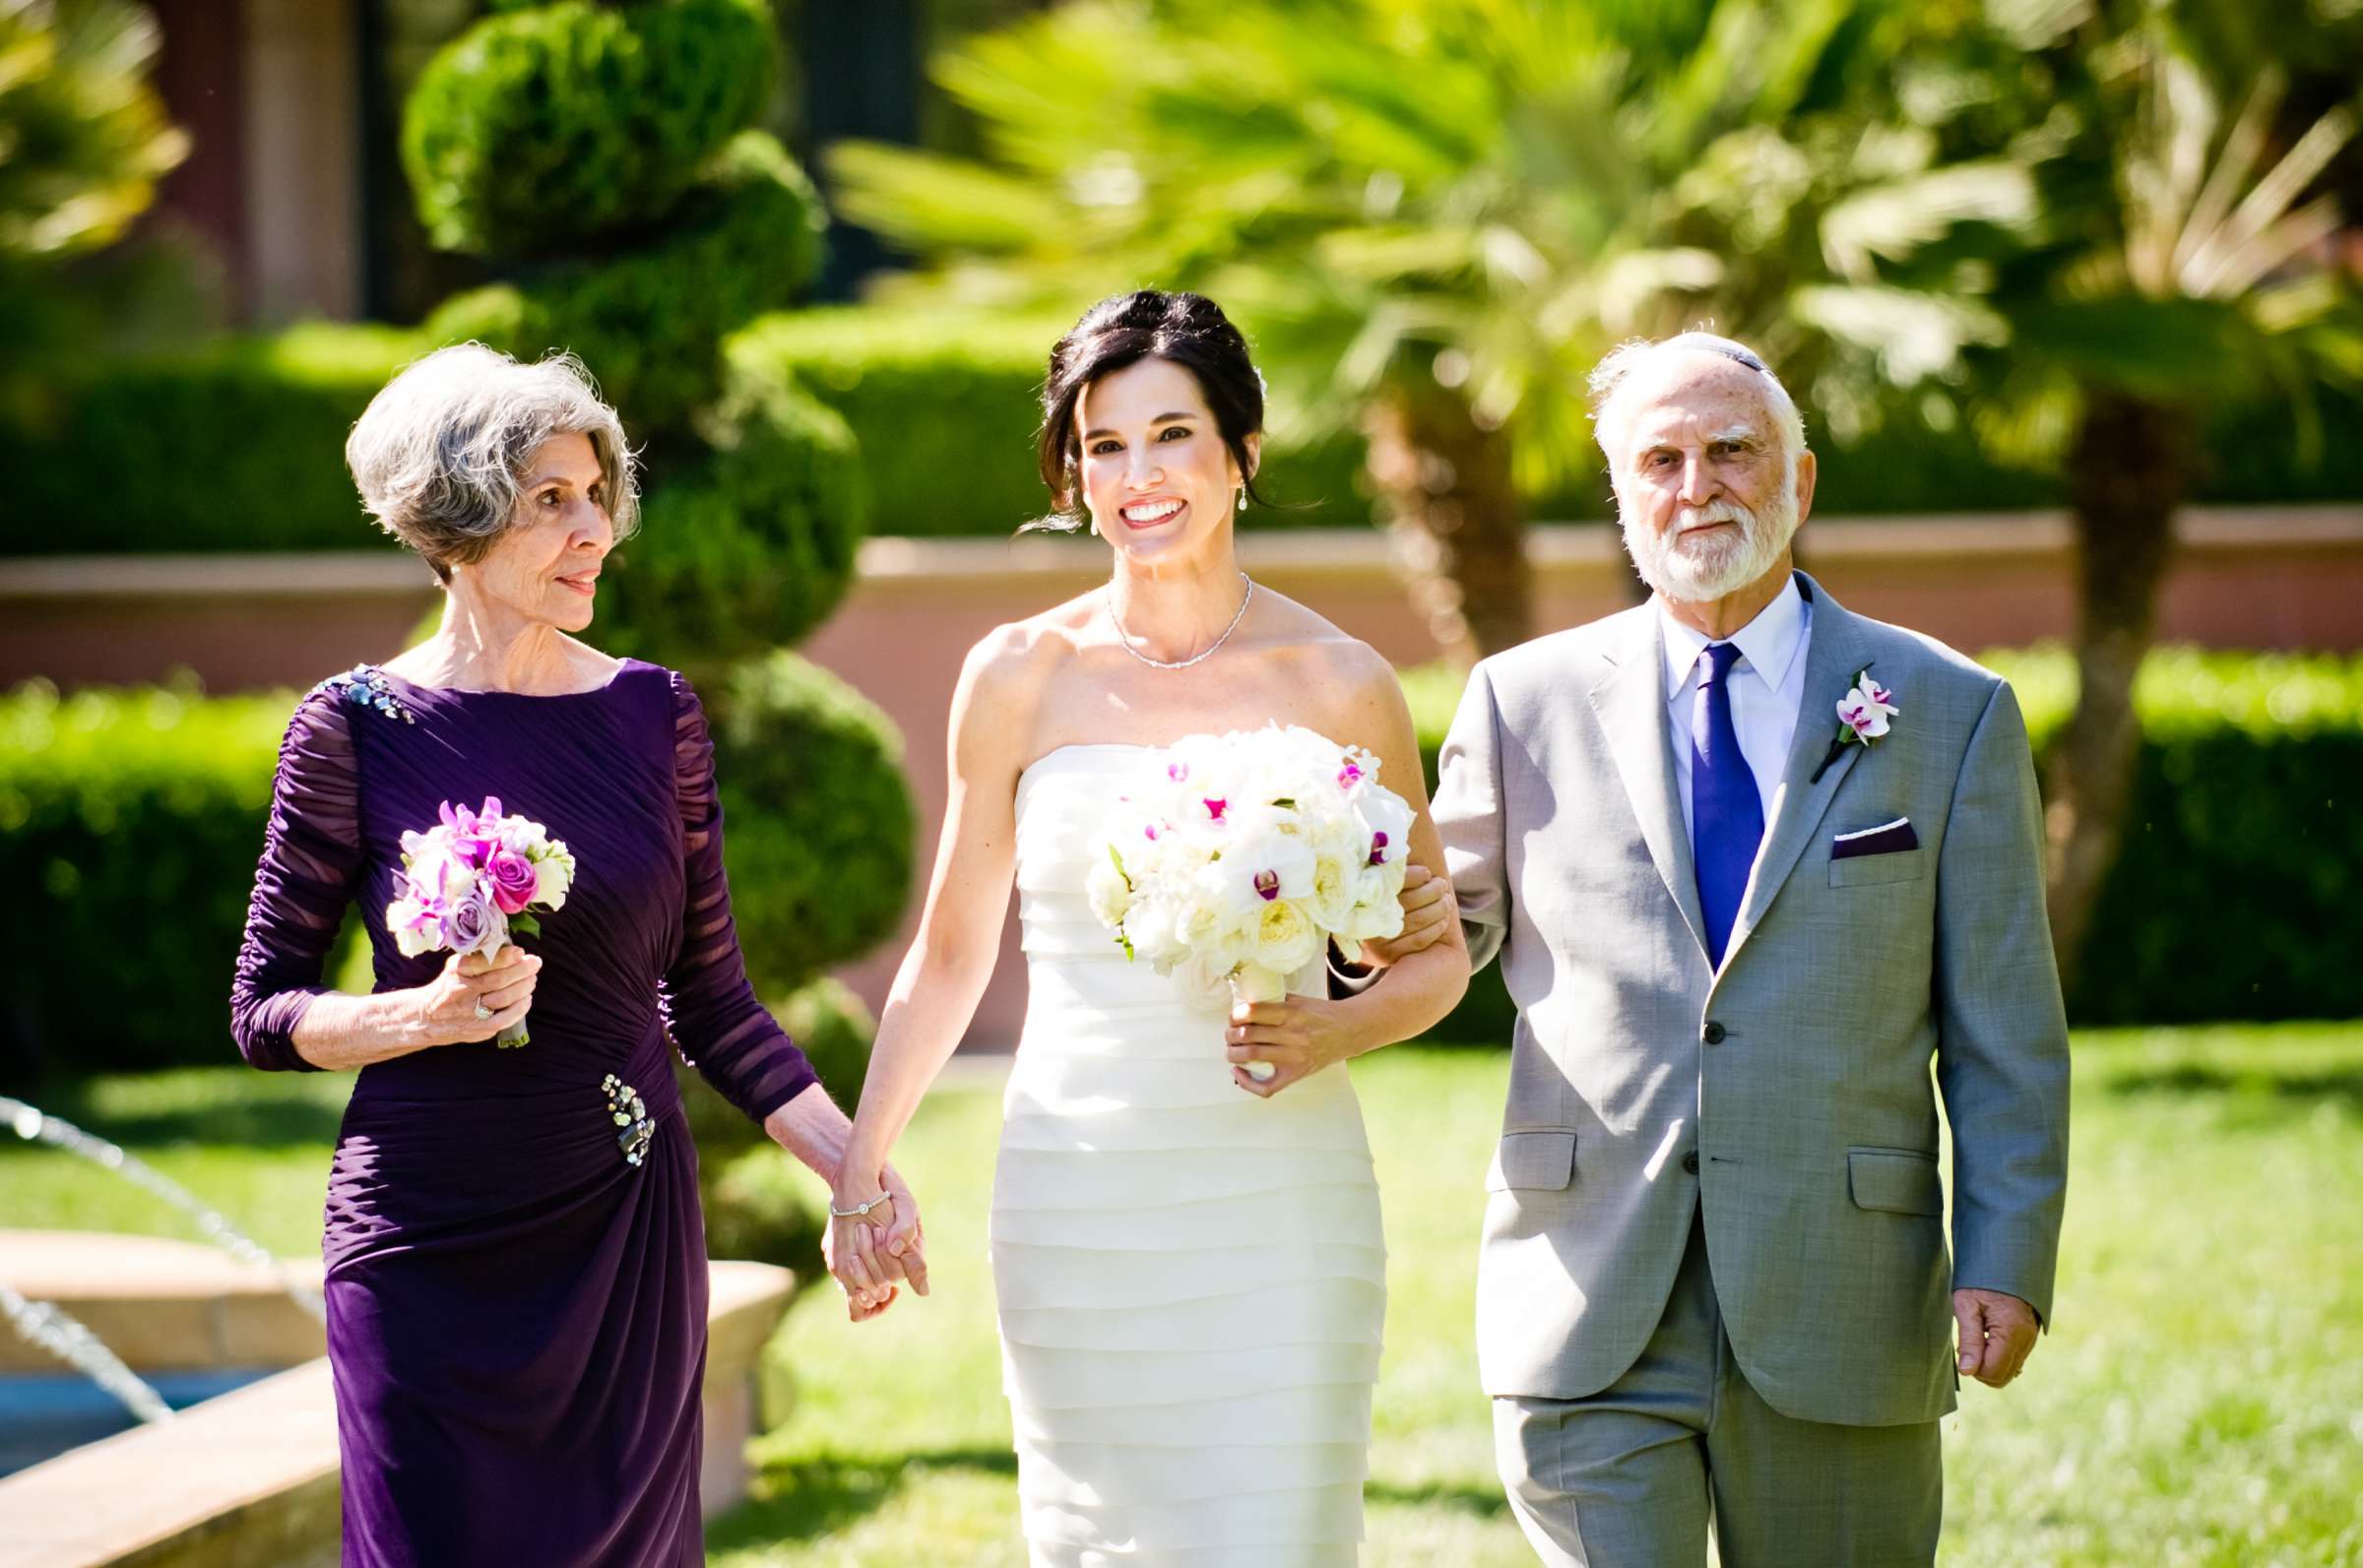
[1938,0,2363,977]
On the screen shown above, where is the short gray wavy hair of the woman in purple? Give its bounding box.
[345,343,640,581]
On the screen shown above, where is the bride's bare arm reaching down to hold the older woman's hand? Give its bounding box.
[829,633,1030,1308]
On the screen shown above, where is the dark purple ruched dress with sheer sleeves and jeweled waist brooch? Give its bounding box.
[231,661,813,1568]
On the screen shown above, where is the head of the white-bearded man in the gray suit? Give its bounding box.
[1605,349,1813,602]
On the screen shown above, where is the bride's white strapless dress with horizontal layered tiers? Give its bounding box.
[990,744,1387,1568]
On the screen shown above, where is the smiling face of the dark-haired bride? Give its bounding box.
[1075,359,1257,560]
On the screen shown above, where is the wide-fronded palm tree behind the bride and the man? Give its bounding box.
[829,0,2034,663]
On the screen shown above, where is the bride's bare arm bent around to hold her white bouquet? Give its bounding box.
[1229,645,1470,1096]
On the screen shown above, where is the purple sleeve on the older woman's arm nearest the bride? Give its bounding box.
[660,675,817,1122]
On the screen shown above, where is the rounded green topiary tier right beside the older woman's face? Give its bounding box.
[598,340,869,670]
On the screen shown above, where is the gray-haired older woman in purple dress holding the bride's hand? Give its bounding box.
[231,345,912,1568]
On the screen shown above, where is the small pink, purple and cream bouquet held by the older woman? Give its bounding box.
[385,798,574,1046]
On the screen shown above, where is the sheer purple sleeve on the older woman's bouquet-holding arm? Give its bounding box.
[229,690,361,1072]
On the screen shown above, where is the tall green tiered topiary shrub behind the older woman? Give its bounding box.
[392,0,915,1128]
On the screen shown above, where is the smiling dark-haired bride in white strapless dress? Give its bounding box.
[829,290,1467,1568]
